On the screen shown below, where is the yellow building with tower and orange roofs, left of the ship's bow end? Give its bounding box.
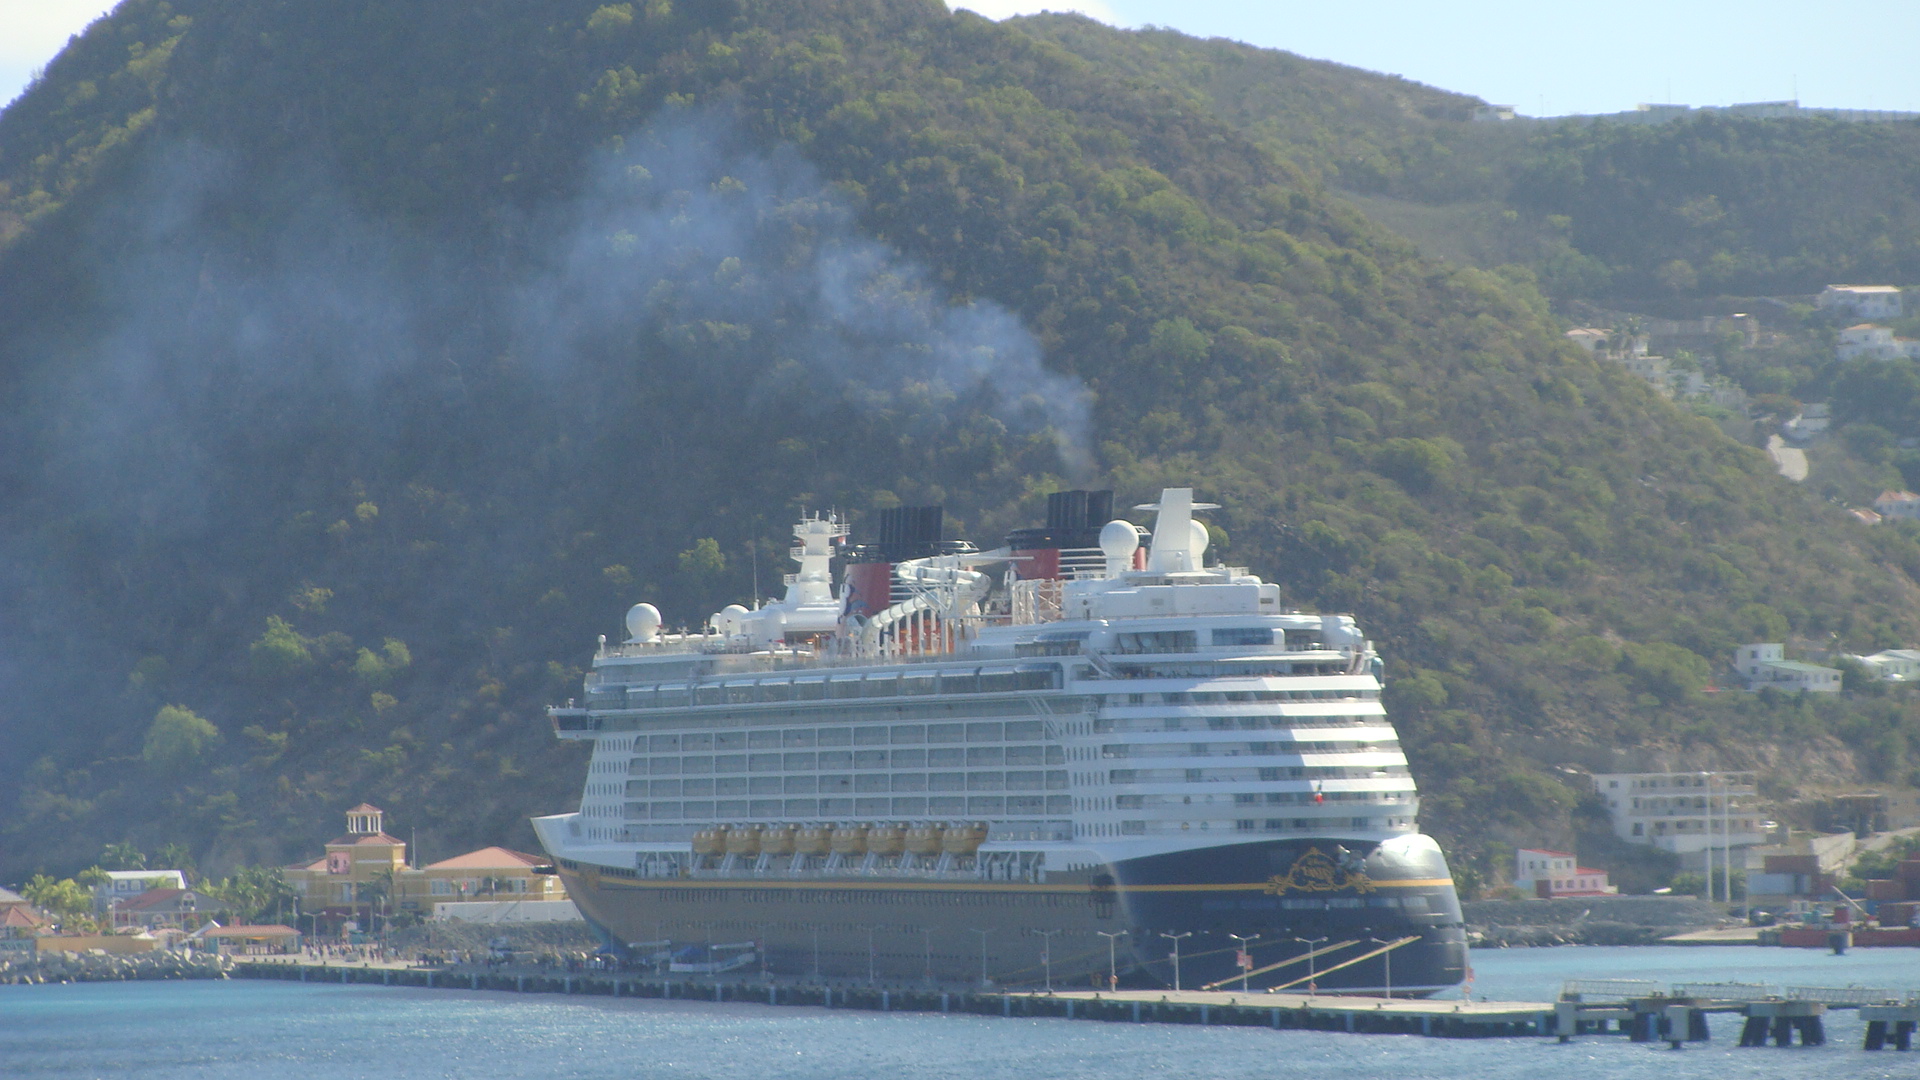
[282,803,566,936]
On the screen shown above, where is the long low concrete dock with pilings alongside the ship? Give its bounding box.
[232,961,1920,1051]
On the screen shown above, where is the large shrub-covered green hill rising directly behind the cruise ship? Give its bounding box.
[0,0,1920,891]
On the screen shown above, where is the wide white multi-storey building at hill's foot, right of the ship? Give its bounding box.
[1594,773,1766,867]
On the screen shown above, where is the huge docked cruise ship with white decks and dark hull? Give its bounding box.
[534,488,1467,995]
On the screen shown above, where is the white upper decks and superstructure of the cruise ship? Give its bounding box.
[536,488,1430,880]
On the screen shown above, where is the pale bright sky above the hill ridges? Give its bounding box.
[0,0,1920,115]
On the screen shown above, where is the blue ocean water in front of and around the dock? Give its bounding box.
[0,947,1920,1080]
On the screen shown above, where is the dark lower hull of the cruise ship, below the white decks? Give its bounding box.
[557,842,1467,995]
